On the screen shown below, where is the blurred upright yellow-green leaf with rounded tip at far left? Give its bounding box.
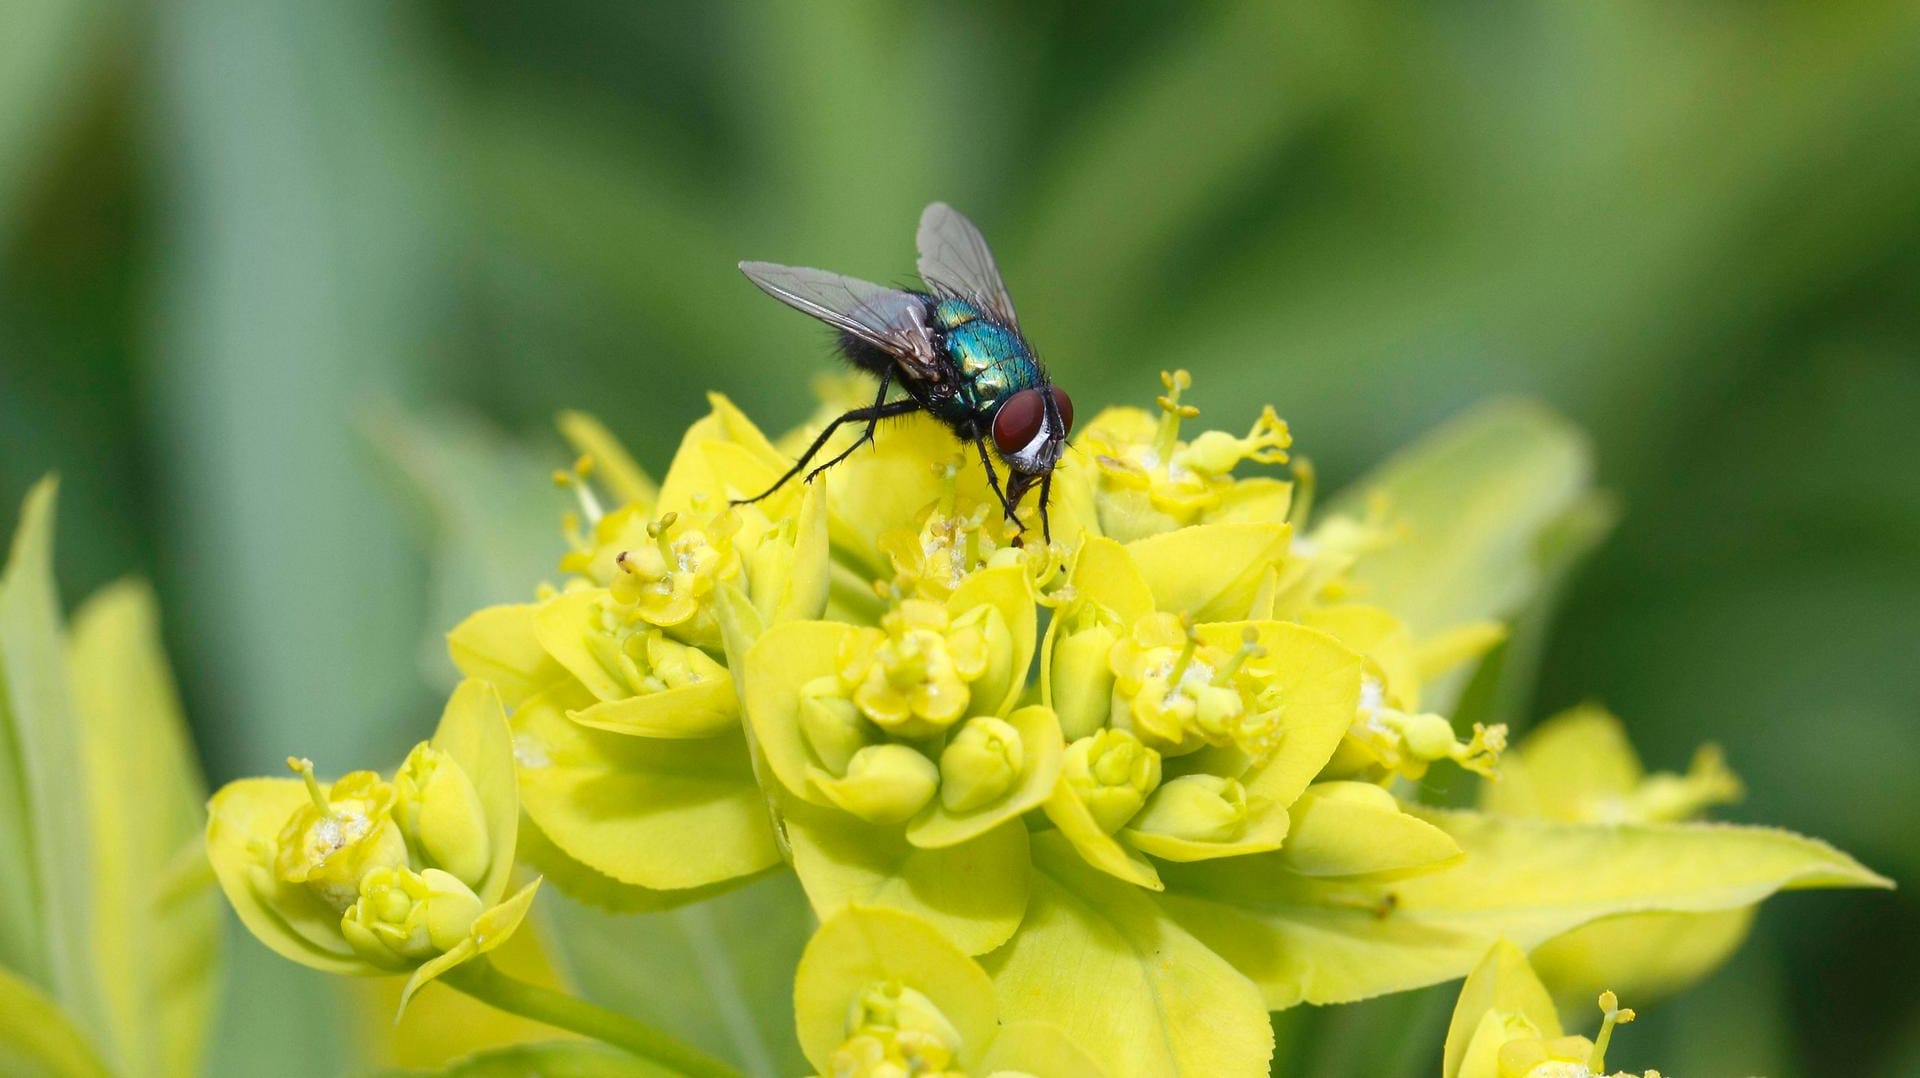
[69,580,223,1074]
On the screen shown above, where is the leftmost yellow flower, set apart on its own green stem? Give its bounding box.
[207,680,540,1005]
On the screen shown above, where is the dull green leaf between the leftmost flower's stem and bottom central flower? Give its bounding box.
[541,868,814,1074]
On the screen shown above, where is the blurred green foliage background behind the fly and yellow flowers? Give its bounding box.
[0,0,1920,1076]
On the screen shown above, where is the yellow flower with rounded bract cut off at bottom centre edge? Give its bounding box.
[793,905,1100,1078]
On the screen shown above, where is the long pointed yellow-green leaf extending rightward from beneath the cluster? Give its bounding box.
[1160,809,1891,1011]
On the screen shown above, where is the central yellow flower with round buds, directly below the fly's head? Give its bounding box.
[743,565,1066,953]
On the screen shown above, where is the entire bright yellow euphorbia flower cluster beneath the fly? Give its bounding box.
[187,373,1878,1078]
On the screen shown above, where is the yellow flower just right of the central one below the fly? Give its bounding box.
[1041,525,1459,890]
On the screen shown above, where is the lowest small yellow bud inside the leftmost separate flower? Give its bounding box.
[340,867,486,968]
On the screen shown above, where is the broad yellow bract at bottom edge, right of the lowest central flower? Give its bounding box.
[981,834,1273,1078]
